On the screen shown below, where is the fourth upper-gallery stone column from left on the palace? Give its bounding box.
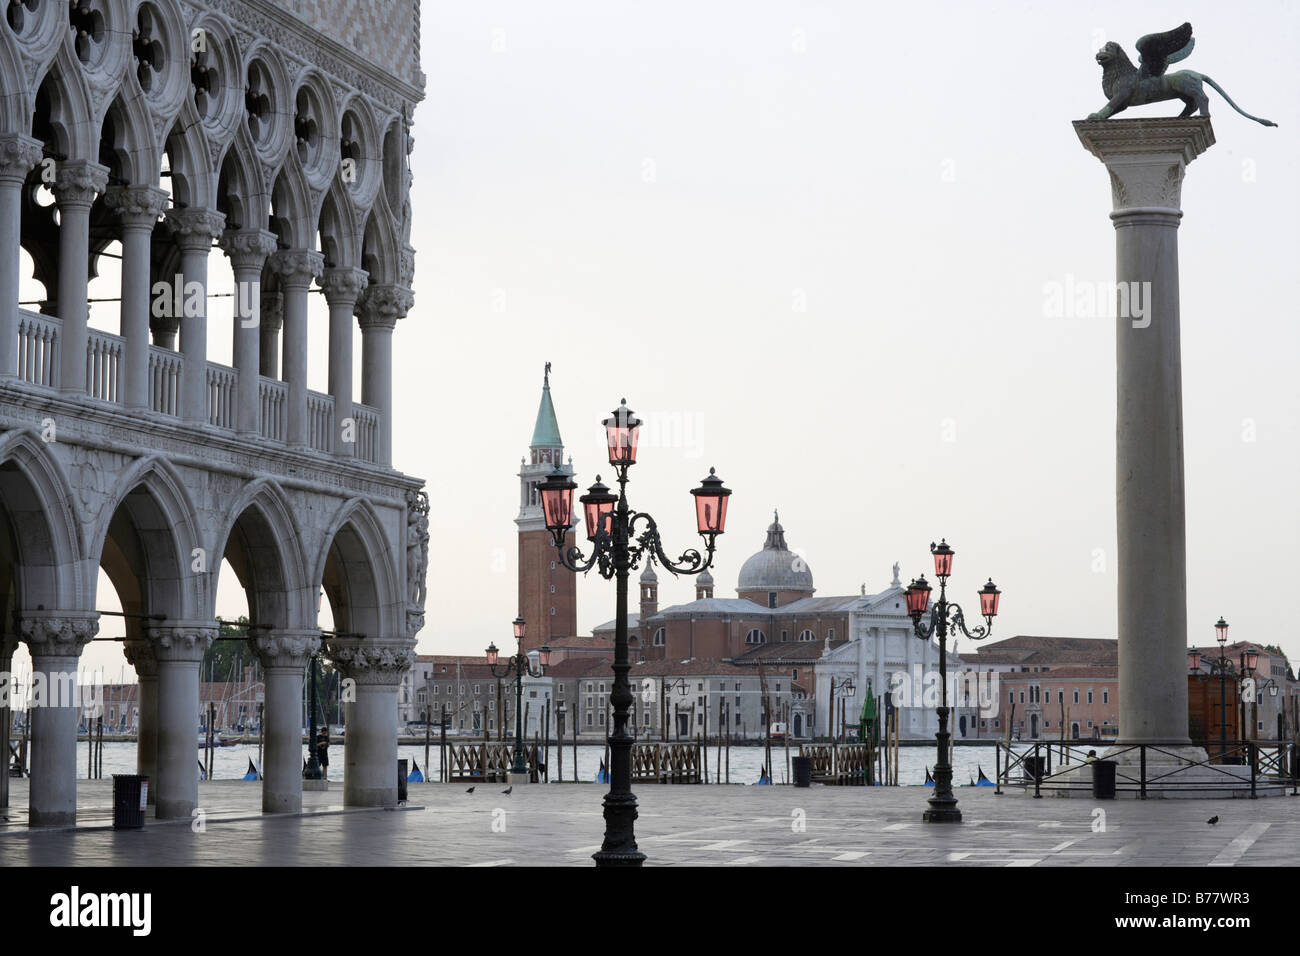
[169,207,226,424]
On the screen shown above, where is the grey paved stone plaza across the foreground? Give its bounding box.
[0,780,1300,866]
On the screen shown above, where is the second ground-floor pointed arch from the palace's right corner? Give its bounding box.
[213,479,316,630]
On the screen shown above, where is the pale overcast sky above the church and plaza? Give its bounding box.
[58,0,1300,674]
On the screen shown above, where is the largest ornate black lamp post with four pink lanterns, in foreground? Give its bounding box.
[540,399,731,866]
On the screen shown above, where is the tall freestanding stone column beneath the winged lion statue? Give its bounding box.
[1074,117,1214,744]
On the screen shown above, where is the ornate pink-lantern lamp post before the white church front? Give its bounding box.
[904,540,1002,823]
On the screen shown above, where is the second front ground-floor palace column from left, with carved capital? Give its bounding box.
[148,622,217,819]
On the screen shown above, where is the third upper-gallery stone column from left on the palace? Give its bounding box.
[104,186,168,408]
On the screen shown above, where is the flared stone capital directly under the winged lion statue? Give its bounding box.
[1074,116,1214,216]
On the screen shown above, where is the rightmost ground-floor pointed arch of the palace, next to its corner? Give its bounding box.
[312,498,406,639]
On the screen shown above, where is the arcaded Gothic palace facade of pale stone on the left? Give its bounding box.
[0,0,428,826]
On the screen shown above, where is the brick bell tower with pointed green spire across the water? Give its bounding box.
[515,362,577,650]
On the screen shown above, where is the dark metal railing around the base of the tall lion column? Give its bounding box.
[995,740,1300,800]
